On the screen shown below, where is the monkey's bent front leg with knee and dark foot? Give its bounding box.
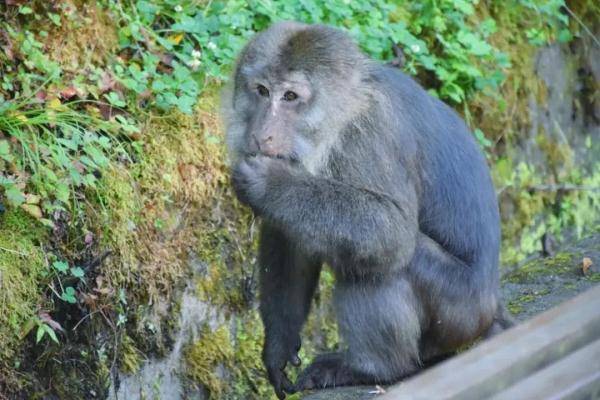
[296,274,420,390]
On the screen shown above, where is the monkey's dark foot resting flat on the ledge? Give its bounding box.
[295,353,366,391]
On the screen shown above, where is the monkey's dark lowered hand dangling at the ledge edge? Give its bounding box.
[263,335,300,399]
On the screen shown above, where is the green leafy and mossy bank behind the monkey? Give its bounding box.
[0,0,600,398]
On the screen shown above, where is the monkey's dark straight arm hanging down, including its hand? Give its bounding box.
[259,223,321,398]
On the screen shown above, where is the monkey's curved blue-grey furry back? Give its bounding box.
[374,67,500,284]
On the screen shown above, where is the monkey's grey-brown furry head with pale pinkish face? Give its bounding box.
[223,22,369,171]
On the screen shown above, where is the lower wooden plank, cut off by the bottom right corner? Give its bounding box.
[490,339,600,400]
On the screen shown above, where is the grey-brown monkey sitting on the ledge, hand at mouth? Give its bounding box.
[222,22,512,399]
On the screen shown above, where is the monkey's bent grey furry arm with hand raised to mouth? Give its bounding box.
[234,157,418,272]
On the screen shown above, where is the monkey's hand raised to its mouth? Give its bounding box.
[232,155,293,214]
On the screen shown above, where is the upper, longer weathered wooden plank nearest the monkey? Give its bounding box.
[381,285,600,400]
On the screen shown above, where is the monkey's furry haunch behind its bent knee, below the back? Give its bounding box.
[407,234,508,362]
